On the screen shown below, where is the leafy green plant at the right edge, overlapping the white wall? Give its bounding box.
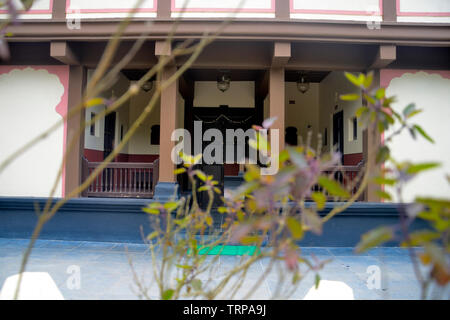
[343,74,450,299]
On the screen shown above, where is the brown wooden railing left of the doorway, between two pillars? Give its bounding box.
[83,158,159,198]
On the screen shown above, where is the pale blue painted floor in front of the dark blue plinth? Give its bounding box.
[0,238,450,299]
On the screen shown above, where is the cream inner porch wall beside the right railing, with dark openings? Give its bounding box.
[319,71,363,154]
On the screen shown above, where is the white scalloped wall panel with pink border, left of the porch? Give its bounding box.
[0,68,64,197]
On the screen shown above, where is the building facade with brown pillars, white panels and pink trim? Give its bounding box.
[0,0,450,202]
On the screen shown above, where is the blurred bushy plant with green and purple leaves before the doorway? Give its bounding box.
[135,101,368,299]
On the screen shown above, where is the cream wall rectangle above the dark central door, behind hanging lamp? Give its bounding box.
[194,81,255,108]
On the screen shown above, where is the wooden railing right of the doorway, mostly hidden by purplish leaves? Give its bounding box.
[313,162,365,201]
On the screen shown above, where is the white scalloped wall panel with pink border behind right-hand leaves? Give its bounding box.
[386,72,450,201]
